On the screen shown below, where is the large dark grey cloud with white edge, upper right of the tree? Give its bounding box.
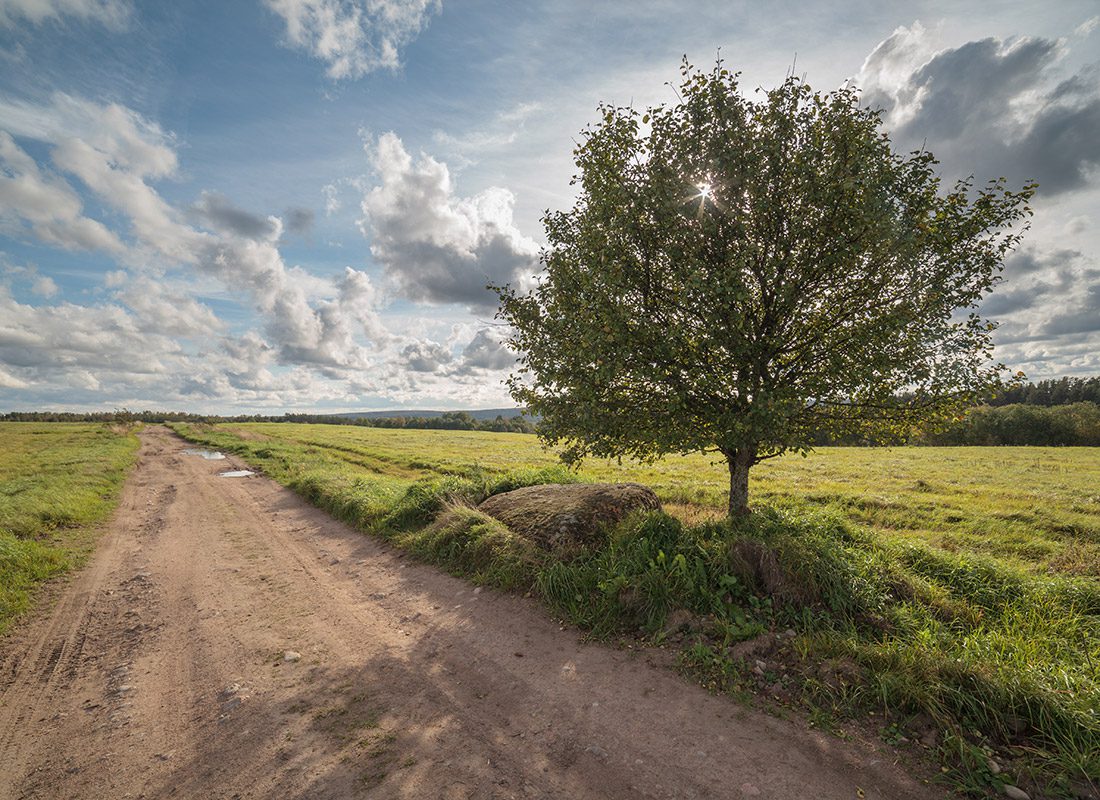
[856,23,1100,196]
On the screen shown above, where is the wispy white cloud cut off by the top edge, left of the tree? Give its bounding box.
[265,0,440,79]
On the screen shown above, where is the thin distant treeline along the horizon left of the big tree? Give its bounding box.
[0,408,535,434]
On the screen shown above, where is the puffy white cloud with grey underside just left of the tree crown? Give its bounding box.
[360,133,538,309]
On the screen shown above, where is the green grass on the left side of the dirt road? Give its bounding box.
[0,423,139,633]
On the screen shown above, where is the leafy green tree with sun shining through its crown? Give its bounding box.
[497,61,1034,514]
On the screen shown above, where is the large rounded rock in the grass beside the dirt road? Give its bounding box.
[477,483,661,552]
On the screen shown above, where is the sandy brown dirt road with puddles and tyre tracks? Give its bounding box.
[0,428,942,800]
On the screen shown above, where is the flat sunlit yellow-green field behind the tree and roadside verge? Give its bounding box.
[171,423,1100,578]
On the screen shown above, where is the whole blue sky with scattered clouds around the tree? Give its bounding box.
[0,0,1100,414]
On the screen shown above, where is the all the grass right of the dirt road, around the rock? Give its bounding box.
[174,424,1100,797]
